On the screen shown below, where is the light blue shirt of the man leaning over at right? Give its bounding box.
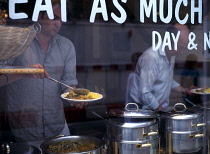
[131,48,180,110]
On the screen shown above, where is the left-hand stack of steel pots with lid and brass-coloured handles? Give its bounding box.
[107,103,159,154]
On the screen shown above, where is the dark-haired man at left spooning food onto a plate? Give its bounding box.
[2,0,84,149]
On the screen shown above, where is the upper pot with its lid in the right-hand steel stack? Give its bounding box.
[160,103,206,133]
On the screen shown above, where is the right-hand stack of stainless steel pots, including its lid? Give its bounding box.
[159,103,206,154]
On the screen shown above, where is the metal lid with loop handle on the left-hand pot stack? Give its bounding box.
[108,103,157,118]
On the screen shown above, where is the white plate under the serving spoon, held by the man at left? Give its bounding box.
[61,92,103,102]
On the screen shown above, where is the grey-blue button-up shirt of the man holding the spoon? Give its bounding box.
[7,35,77,140]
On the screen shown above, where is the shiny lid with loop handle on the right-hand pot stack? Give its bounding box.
[161,103,202,120]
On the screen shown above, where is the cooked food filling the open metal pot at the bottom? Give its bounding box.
[47,140,98,153]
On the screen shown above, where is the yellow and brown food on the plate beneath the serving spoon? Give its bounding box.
[65,90,100,100]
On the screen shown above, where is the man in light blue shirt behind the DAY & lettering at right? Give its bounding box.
[131,24,194,110]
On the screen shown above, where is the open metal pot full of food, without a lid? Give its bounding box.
[41,136,104,154]
